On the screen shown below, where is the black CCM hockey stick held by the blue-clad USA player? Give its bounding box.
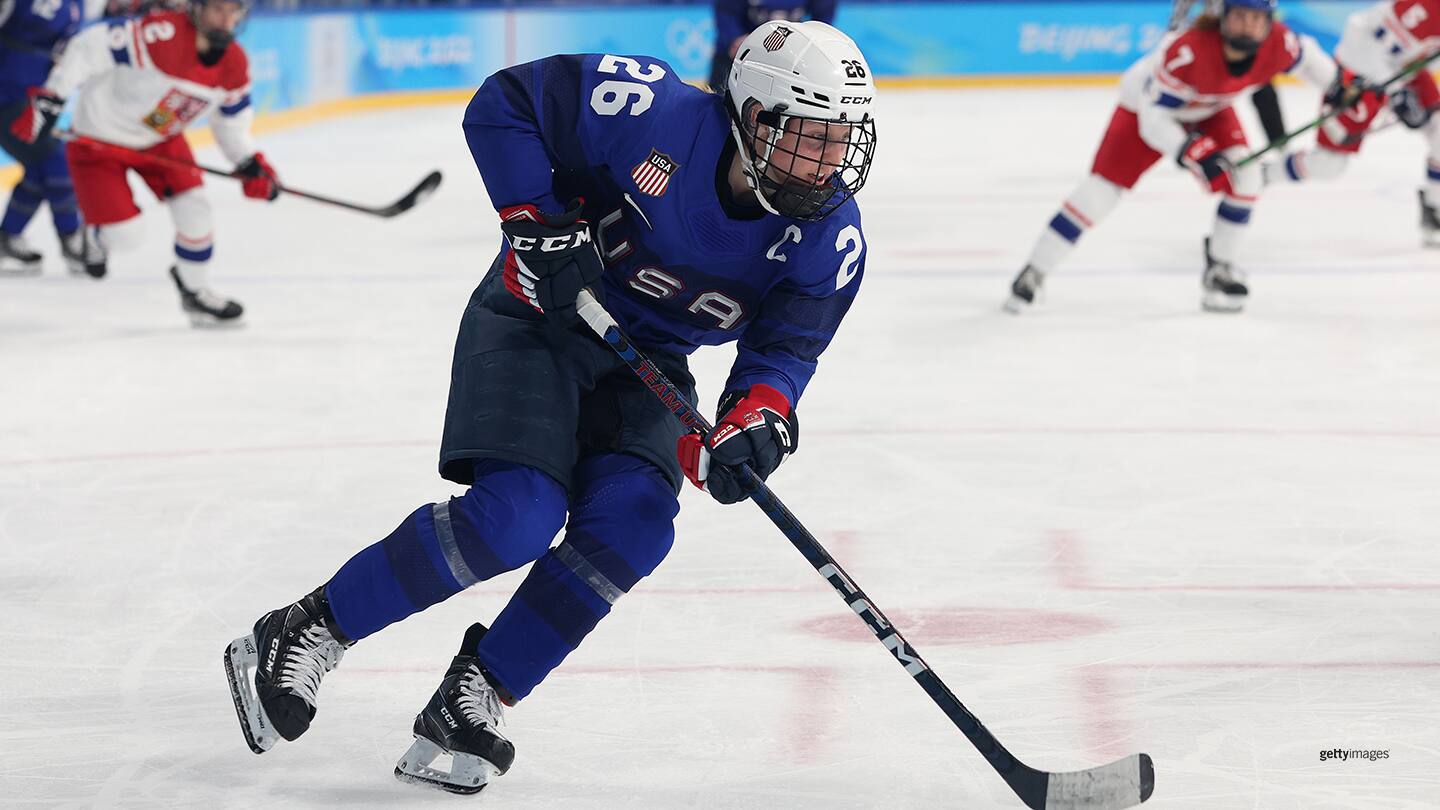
[576,290,1155,810]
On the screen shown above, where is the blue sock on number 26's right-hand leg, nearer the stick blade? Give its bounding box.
[478,454,680,703]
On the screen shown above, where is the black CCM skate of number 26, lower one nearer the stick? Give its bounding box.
[395,624,516,794]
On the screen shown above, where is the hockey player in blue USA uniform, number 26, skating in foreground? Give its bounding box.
[226,22,876,793]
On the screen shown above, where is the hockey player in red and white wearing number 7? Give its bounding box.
[1005,0,1336,313]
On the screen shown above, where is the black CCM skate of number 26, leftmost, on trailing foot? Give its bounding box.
[225,588,351,754]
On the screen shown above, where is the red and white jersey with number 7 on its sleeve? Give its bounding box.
[1120,22,1335,154]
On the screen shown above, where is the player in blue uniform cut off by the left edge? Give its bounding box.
[0,0,94,274]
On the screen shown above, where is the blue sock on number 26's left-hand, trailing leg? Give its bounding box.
[325,461,564,641]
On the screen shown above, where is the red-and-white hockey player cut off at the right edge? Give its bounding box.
[1264,0,1440,248]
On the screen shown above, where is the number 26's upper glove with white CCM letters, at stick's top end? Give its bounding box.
[500,199,605,326]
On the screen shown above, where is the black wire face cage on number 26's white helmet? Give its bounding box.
[739,110,876,222]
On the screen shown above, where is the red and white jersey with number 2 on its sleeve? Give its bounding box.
[45,12,255,163]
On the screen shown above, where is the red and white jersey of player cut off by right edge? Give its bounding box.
[1335,0,1440,84]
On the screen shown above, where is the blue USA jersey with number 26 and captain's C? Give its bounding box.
[464,53,865,405]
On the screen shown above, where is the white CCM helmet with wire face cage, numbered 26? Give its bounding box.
[726,20,876,222]
